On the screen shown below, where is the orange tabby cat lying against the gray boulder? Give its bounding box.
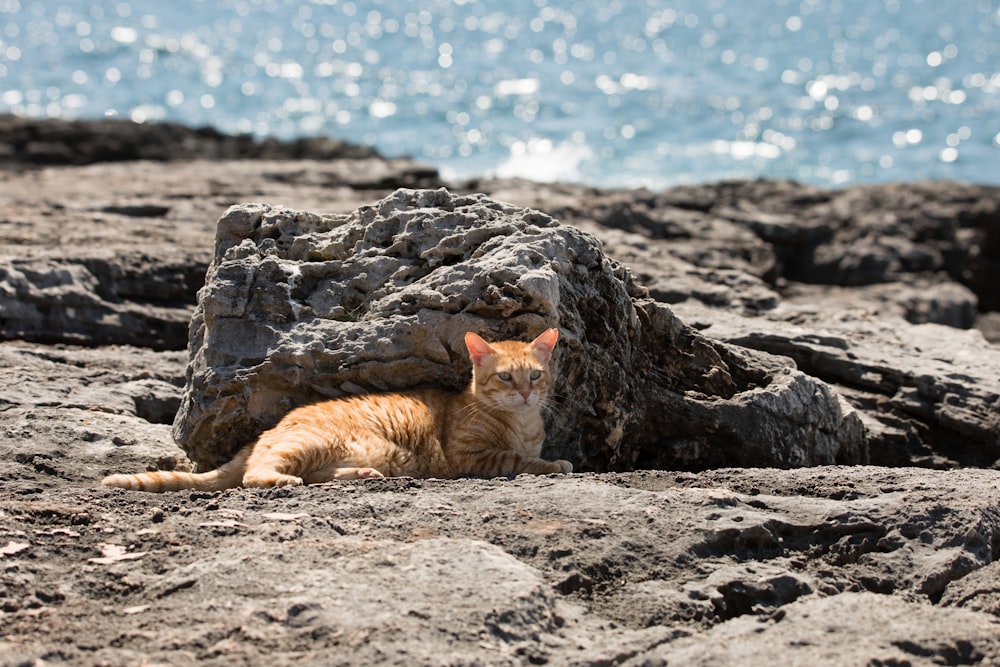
[103,329,573,491]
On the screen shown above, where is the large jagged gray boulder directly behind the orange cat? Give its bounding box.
[174,189,867,470]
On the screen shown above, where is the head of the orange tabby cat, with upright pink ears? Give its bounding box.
[465,329,559,412]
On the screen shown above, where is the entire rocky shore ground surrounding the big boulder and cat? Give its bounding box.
[0,118,1000,665]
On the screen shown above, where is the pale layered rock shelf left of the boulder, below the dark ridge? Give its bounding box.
[0,138,436,349]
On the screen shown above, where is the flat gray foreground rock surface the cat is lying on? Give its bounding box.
[0,343,1000,667]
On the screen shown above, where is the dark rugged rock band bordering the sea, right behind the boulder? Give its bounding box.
[476,181,1000,328]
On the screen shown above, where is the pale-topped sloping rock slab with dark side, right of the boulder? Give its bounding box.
[676,305,1000,467]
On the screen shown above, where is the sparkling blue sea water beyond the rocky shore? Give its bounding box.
[0,0,1000,188]
